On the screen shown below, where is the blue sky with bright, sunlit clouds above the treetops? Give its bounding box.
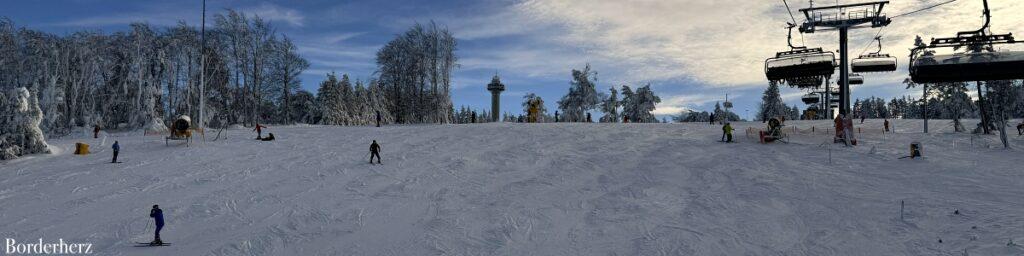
[6,0,1024,120]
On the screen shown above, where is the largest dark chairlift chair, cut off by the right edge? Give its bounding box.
[909,0,1024,83]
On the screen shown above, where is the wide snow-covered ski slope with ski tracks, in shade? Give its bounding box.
[0,120,1024,255]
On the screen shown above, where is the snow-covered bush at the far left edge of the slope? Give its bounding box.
[0,87,50,160]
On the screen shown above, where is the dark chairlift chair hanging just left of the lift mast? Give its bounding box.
[765,24,836,88]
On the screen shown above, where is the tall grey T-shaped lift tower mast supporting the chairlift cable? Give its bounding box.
[800,1,892,115]
